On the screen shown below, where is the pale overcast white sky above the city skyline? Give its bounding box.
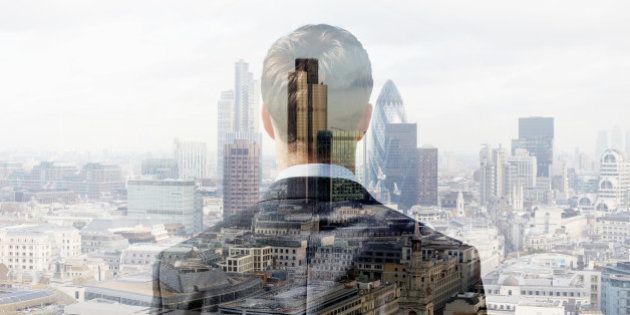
[0,0,630,158]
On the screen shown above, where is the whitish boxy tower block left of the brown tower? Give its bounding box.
[174,139,208,179]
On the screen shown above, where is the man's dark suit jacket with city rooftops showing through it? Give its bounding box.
[153,177,484,314]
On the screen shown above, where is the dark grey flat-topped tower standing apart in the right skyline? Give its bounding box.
[512,117,554,177]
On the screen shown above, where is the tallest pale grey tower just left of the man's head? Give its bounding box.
[231,60,260,133]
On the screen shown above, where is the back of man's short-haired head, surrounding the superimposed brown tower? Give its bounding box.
[261,24,373,141]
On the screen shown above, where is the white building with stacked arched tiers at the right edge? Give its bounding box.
[595,149,630,211]
